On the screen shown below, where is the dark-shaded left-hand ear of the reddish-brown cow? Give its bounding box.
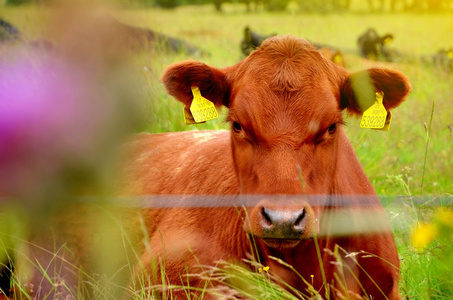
[161,61,230,107]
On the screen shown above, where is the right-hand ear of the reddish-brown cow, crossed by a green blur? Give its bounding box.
[340,68,411,115]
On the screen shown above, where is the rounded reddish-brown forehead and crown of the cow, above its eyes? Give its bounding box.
[226,37,341,144]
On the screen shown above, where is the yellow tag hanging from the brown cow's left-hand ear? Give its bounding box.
[184,86,219,124]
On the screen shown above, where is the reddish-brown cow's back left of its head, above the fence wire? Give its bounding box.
[122,130,238,195]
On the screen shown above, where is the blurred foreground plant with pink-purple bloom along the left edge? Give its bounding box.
[0,1,148,298]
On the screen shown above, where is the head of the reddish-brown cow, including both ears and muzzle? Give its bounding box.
[162,36,410,246]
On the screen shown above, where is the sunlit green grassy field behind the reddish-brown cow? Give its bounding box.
[0,2,453,299]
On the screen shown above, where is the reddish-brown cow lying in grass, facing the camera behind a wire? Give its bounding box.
[122,36,410,299]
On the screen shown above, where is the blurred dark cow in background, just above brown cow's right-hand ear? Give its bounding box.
[357,28,393,60]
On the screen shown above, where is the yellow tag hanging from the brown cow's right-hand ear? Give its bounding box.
[360,92,392,130]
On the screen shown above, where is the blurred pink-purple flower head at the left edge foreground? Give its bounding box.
[0,56,134,195]
